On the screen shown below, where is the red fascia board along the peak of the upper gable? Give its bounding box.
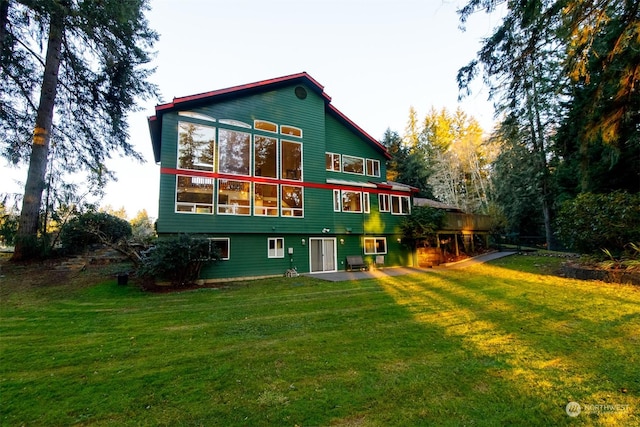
[156,72,331,113]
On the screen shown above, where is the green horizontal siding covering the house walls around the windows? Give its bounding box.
[157,80,411,278]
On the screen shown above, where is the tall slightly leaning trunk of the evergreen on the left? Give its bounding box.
[12,10,64,261]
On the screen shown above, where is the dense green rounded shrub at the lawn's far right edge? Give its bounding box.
[556,191,640,255]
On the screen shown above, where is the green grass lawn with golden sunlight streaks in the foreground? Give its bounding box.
[0,256,640,426]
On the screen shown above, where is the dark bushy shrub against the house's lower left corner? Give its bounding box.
[137,234,220,286]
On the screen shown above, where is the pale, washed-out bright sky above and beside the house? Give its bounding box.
[0,0,499,221]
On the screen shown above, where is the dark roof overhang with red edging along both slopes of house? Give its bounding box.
[148,72,391,163]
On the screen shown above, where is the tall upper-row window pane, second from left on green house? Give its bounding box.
[218,129,251,175]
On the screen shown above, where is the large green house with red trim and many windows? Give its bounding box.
[149,72,415,280]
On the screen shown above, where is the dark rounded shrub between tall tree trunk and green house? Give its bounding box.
[60,212,132,253]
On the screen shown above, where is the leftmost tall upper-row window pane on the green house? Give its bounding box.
[178,122,216,171]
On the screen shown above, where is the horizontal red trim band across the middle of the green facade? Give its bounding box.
[160,167,409,196]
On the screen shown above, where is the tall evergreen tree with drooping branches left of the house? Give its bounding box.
[0,0,157,260]
